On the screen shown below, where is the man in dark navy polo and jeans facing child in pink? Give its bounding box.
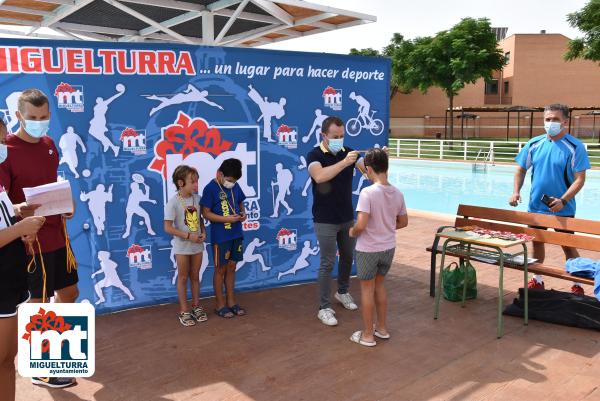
[306,117,364,326]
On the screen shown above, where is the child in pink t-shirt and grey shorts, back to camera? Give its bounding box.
[350,149,408,347]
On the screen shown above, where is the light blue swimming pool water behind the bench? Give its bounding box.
[389,159,600,220]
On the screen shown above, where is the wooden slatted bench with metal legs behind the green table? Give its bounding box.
[427,205,600,297]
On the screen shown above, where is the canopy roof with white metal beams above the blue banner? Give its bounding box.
[0,0,377,46]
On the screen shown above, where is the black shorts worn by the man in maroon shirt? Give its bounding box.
[27,248,79,298]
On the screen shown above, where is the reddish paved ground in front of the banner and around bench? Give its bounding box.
[17,212,600,401]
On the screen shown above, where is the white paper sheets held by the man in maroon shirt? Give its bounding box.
[23,180,73,216]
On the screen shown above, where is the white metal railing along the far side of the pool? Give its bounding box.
[389,138,600,167]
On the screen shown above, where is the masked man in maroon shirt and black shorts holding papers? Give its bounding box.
[0,89,79,387]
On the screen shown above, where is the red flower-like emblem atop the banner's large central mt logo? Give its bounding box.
[148,111,233,179]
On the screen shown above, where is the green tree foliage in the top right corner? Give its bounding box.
[565,0,600,61]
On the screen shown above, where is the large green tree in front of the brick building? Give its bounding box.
[351,19,504,138]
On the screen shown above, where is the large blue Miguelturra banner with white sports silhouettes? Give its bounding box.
[0,39,390,313]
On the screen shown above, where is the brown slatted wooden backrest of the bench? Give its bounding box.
[454,205,600,251]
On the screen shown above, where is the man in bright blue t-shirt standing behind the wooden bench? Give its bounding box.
[509,104,590,295]
